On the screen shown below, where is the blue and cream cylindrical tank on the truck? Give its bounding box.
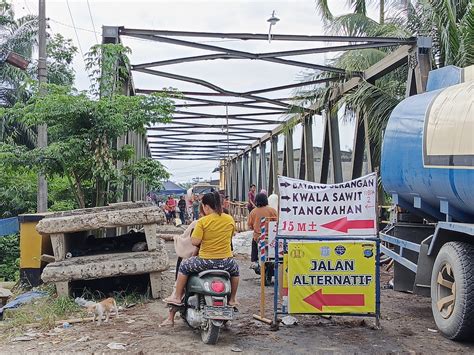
[381,67,474,223]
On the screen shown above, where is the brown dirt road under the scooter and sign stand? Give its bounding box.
[0,241,474,354]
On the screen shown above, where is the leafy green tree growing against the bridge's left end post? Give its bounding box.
[0,79,174,207]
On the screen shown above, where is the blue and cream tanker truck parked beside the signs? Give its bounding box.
[380,66,474,340]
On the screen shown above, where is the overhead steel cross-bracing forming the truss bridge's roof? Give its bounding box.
[103,26,417,160]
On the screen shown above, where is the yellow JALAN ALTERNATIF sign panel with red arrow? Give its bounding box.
[288,240,377,314]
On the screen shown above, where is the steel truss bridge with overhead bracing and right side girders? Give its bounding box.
[103,26,431,200]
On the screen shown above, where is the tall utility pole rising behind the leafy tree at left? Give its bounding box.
[37,0,48,212]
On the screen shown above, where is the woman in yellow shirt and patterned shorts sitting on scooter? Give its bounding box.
[164,192,239,306]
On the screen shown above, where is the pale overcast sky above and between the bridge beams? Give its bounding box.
[12,0,378,182]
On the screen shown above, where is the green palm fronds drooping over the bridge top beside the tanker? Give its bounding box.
[297,0,474,166]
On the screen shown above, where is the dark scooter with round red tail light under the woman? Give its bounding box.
[173,270,234,344]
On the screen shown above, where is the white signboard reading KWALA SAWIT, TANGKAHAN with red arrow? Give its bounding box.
[278,173,377,237]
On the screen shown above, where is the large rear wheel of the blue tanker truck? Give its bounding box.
[431,242,474,340]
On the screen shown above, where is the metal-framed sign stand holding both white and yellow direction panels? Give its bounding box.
[272,173,380,327]
